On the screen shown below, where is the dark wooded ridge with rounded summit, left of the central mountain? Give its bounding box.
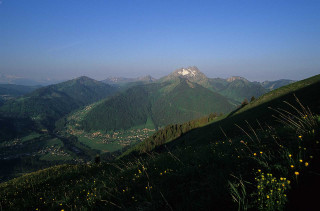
[0,77,115,129]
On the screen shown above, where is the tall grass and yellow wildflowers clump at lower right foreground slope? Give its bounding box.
[229,97,319,210]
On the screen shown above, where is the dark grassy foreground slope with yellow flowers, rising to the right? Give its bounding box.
[0,76,320,210]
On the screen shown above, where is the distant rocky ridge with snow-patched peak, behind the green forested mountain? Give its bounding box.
[102,66,294,104]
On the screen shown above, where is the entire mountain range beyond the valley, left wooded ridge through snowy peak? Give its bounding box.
[0,67,292,137]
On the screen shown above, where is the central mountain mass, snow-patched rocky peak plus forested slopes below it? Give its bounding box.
[71,67,284,132]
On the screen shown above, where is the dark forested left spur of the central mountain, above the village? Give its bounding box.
[80,84,159,131]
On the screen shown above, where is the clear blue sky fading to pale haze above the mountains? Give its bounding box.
[0,0,320,81]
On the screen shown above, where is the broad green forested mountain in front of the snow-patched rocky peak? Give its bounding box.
[79,79,233,131]
